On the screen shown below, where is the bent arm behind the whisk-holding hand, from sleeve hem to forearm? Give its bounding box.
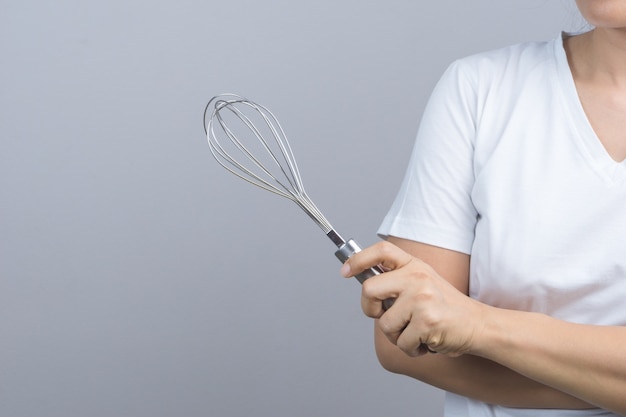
[346,237,596,409]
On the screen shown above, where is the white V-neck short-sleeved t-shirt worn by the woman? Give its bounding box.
[379,33,626,417]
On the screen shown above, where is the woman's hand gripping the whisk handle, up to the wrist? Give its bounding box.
[341,241,487,356]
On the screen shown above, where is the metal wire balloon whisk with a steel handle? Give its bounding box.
[204,94,393,308]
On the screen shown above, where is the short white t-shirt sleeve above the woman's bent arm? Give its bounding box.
[378,61,478,254]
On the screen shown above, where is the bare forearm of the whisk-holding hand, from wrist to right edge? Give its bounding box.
[470,306,626,415]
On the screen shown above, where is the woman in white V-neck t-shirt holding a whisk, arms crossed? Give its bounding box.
[341,0,626,416]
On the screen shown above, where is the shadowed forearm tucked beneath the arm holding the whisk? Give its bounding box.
[375,328,594,409]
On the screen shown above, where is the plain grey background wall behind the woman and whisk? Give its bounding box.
[0,0,582,417]
